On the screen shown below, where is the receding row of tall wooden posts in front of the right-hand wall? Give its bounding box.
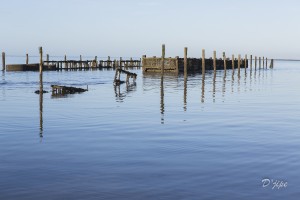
[161,44,274,74]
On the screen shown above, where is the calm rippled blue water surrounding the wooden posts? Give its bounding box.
[0,62,300,200]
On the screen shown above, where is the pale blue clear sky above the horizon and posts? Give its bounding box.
[0,0,300,59]
